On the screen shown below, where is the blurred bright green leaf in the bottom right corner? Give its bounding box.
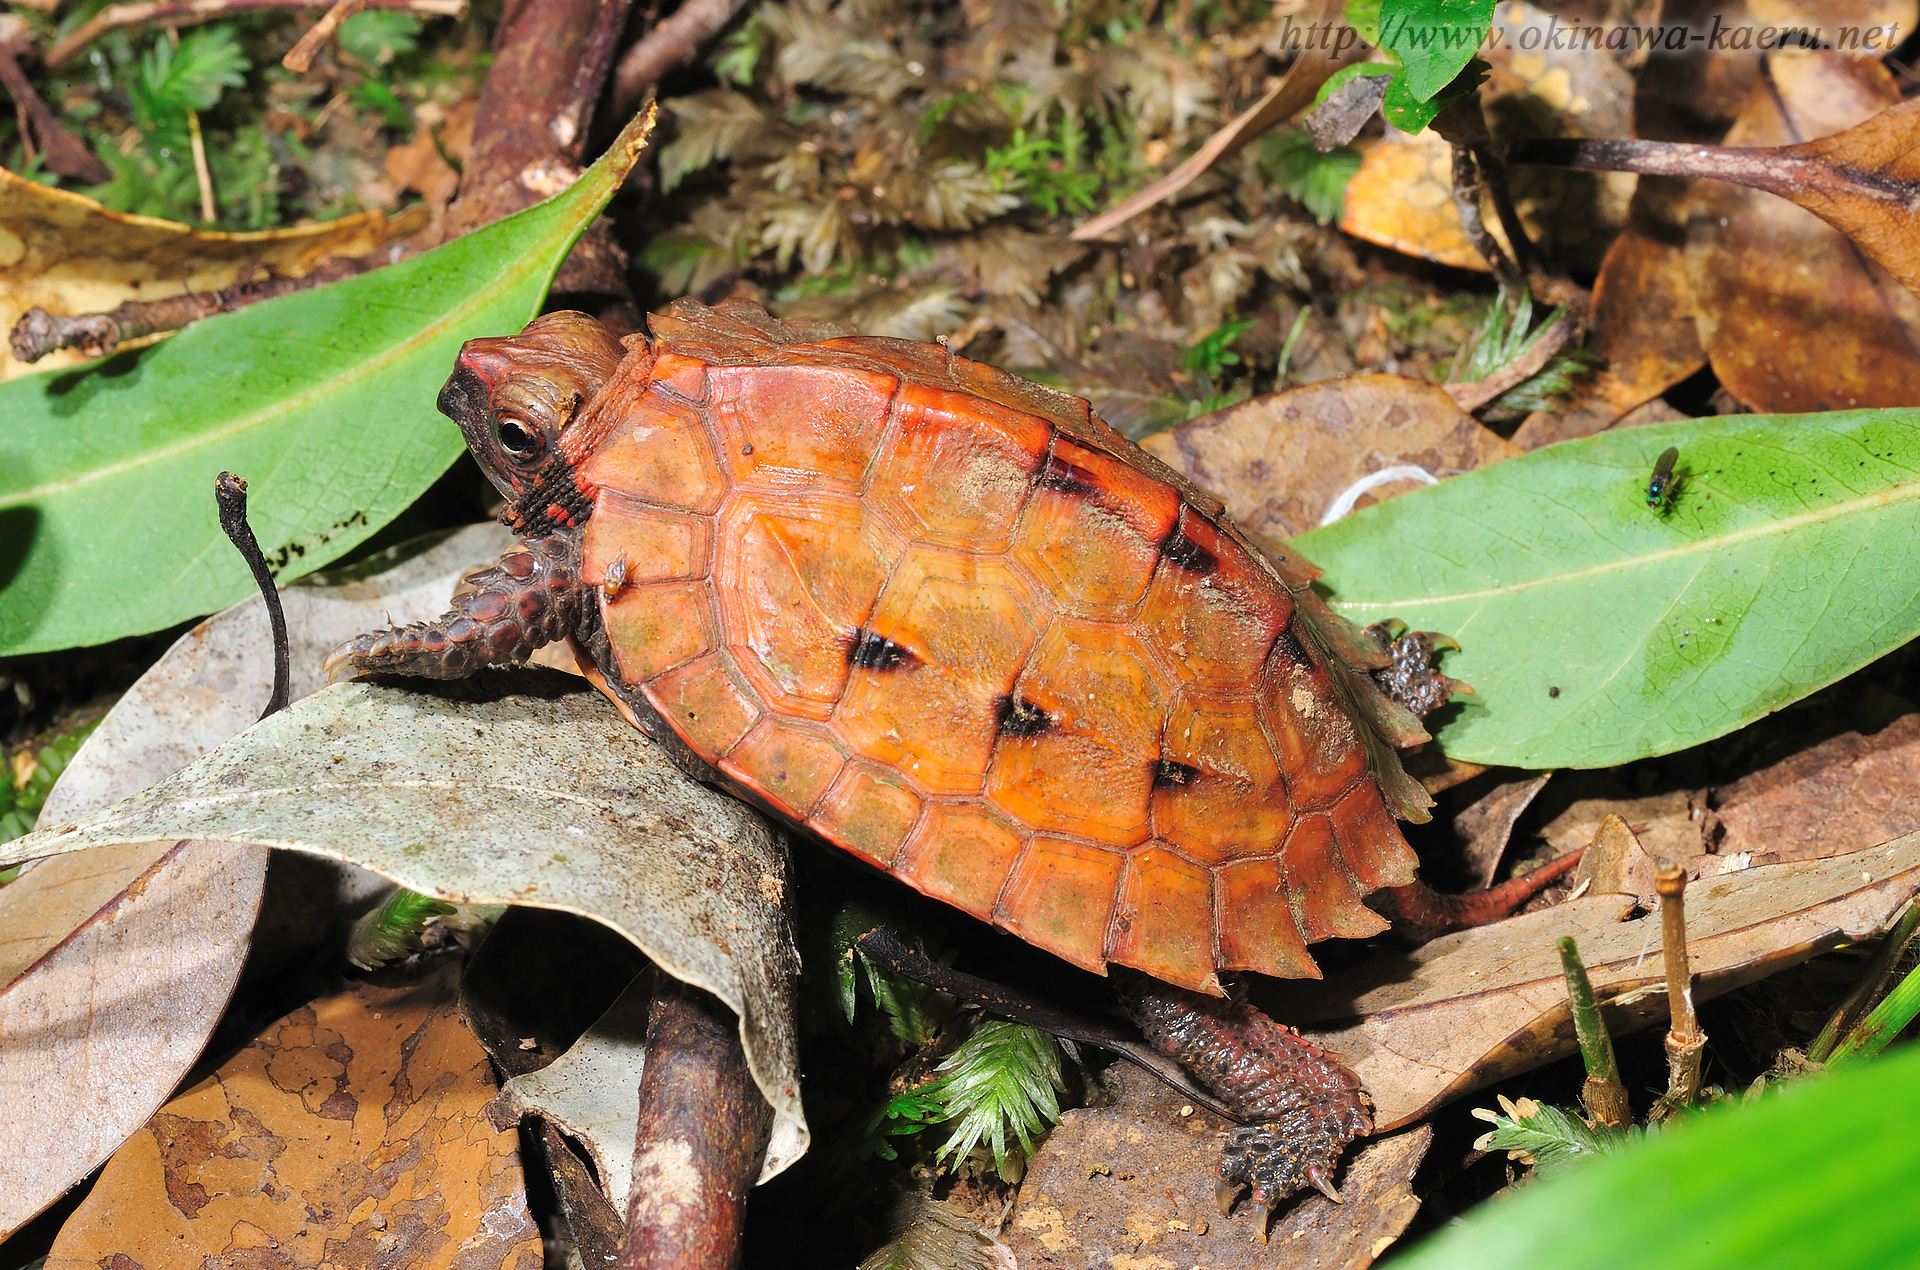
[1394,1047,1920,1270]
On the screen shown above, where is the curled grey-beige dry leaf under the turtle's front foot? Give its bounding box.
[0,671,806,1178]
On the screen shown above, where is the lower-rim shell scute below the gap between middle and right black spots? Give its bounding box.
[995,838,1127,974]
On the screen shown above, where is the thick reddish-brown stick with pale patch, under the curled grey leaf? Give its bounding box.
[620,974,774,1270]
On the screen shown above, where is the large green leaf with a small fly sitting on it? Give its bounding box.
[1298,409,1920,769]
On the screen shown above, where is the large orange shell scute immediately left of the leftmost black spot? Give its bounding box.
[718,494,889,719]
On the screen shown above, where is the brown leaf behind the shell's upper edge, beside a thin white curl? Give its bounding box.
[1140,375,1519,538]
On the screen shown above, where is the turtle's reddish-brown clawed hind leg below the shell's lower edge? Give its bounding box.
[1123,980,1373,1243]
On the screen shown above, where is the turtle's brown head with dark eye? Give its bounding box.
[440,311,622,534]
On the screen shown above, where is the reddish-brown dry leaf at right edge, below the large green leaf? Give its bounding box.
[1713,715,1920,865]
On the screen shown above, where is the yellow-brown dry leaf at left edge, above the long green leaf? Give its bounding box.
[0,169,426,380]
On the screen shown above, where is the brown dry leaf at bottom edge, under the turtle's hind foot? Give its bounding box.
[1006,1062,1432,1270]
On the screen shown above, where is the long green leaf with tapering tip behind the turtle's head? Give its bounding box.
[0,109,647,655]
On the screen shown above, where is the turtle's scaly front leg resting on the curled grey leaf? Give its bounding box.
[326,534,588,678]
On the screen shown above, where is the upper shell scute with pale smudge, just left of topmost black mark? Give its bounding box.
[868,382,1052,551]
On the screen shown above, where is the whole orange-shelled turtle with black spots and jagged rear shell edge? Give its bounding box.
[330,300,1512,1235]
